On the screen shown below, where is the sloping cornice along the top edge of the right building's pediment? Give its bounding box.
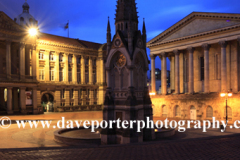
[147,12,240,47]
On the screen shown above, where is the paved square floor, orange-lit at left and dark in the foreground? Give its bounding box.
[0,112,240,160]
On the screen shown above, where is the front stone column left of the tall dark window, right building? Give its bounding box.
[187,47,194,94]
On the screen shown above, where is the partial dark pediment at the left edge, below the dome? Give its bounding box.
[0,12,23,32]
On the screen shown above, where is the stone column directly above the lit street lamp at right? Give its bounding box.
[219,41,227,92]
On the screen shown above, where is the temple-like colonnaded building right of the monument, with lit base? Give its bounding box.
[147,12,240,121]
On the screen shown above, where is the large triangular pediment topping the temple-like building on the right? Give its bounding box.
[148,12,240,45]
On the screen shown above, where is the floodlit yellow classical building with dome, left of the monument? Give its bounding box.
[0,2,107,114]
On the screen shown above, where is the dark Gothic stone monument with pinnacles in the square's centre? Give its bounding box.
[101,0,155,144]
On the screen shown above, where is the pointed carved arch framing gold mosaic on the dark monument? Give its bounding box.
[105,48,131,68]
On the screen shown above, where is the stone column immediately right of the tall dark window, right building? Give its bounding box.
[202,44,210,93]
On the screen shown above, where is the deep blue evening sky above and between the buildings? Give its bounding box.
[0,0,240,77]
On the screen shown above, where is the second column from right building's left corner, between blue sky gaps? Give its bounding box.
[161,52,167,95]
